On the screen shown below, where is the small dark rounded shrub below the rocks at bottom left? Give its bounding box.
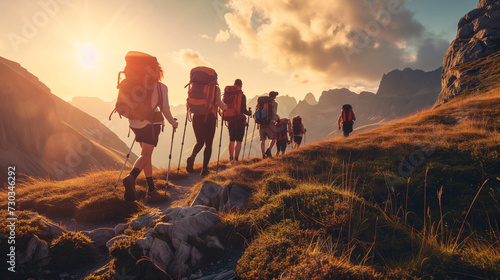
[50,231,94,270]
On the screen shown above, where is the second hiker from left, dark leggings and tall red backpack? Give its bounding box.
[186,66,227,177]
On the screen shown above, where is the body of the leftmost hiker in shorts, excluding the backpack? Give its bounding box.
[122,54,178,201]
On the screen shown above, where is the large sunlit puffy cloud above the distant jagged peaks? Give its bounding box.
[225,0,449,83]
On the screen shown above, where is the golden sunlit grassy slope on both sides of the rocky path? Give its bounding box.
[0,52,500,279]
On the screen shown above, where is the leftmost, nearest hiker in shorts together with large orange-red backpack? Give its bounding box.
[110,51,178,201]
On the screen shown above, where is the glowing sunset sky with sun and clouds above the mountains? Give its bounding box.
[0,0,478,105]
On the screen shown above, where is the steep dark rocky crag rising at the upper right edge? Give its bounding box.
[436,0,500,105]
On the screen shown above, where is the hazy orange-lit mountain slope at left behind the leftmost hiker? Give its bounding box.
[0,55,135,179]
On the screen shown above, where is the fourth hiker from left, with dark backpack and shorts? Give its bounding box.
[255,91,279,159]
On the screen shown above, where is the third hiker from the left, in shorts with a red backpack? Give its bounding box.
[223,79,252,163]
